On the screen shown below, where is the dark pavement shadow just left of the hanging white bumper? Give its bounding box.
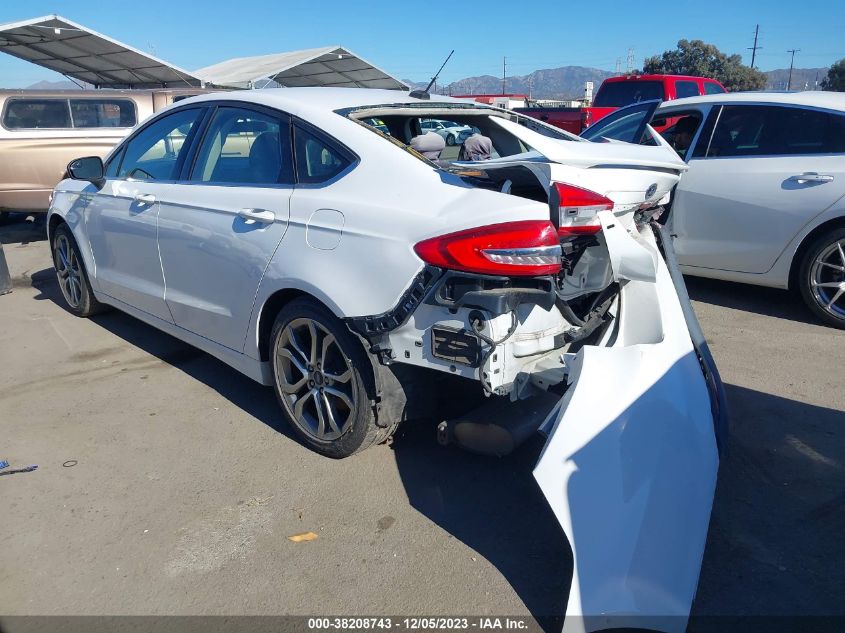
[393,420,573,633]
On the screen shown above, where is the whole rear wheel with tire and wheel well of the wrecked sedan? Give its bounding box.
[270,297,392,458]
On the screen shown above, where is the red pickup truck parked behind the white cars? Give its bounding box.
[515,75,727,135]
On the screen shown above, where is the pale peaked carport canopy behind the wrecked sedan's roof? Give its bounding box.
[194,46,408,90]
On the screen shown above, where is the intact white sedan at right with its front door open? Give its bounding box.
[582,92,845,328]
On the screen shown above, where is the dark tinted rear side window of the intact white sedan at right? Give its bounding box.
[707,105,845,157]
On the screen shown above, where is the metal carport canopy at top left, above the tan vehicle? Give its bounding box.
[0,15,202,88]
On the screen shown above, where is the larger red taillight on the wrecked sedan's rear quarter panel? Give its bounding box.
[414,220,560,277]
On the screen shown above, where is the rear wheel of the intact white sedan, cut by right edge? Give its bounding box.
[798,227,845,329]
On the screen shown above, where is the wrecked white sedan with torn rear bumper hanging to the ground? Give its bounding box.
[48,88,725,630]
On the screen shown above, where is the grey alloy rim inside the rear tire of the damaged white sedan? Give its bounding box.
[273,318,357,442]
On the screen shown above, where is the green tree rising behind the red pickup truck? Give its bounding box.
[643,40,767,91]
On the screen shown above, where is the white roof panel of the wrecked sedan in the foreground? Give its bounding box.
[170,87,488,114]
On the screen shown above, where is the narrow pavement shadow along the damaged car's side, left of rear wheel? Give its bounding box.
[30,268,294,439]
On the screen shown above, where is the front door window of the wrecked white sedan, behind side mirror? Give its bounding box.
[117,108,203,180]
